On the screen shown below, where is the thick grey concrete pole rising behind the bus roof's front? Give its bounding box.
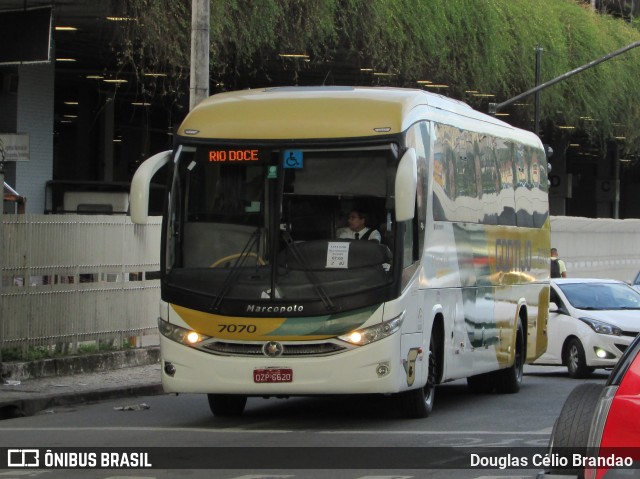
[189,0,210,110]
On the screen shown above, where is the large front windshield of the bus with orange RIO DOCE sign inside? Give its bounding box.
[163,144,398,315]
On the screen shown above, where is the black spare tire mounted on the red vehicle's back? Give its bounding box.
[549,384,604,477]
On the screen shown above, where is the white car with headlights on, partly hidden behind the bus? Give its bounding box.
[534,278,640,378]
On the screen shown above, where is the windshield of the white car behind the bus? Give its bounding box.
[558,283,640,310]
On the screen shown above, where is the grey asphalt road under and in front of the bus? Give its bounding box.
[0,366,608,479]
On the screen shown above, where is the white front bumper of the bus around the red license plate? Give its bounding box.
[160,334,407,396]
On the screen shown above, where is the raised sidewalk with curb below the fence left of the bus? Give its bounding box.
[0,345,163,420]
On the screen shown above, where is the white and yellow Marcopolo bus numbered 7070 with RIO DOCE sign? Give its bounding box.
[130,87,550,418]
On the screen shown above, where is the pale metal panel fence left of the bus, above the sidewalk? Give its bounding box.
[0,215,161,352]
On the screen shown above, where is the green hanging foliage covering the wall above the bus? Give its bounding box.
[120,0,640,151]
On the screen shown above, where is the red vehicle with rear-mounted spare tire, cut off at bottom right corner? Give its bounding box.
[538,335,640,479]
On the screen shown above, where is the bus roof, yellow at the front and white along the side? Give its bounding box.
[178,86,524,140]
